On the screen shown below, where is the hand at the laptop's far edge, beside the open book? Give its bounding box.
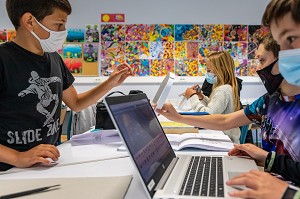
[228,144,268,166]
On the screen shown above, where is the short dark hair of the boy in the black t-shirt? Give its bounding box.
[6,0,72,30]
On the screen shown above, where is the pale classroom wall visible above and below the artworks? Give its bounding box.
[0,0,269,99]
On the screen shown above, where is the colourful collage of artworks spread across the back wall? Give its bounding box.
[0,24,269,76]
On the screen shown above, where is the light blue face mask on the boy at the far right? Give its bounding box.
[278,48,300,86]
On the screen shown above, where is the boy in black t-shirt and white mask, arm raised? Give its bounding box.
[0,0,131,171]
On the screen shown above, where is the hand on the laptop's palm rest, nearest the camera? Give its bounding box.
[226,170,288,199]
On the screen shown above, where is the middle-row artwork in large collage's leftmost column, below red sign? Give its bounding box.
[101,41,125,59]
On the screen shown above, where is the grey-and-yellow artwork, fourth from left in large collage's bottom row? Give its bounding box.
[175,60,199,76]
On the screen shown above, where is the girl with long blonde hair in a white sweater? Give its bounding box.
[183,51,241,143]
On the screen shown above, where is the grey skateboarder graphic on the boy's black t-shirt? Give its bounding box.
[18,71,61,126]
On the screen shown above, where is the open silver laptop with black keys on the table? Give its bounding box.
[105,94,257,198]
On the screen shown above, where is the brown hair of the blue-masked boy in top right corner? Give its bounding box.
[262,0,300,27]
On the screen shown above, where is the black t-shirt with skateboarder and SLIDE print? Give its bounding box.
[0,42,74,171]
